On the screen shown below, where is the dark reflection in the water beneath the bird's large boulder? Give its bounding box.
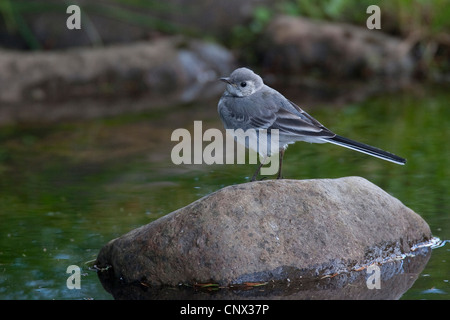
[102,248,431,301]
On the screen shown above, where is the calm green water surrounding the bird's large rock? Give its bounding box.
[0,87,450,299]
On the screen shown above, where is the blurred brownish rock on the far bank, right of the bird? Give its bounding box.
[259,16,415,81]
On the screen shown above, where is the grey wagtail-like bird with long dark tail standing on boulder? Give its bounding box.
[217,67,406,181]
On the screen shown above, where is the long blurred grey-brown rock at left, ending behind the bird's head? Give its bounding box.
[0,37,234,102]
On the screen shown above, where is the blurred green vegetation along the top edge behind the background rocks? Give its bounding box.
[0,0,450,73]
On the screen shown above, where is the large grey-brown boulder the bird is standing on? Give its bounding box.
[96,177,431,286]
